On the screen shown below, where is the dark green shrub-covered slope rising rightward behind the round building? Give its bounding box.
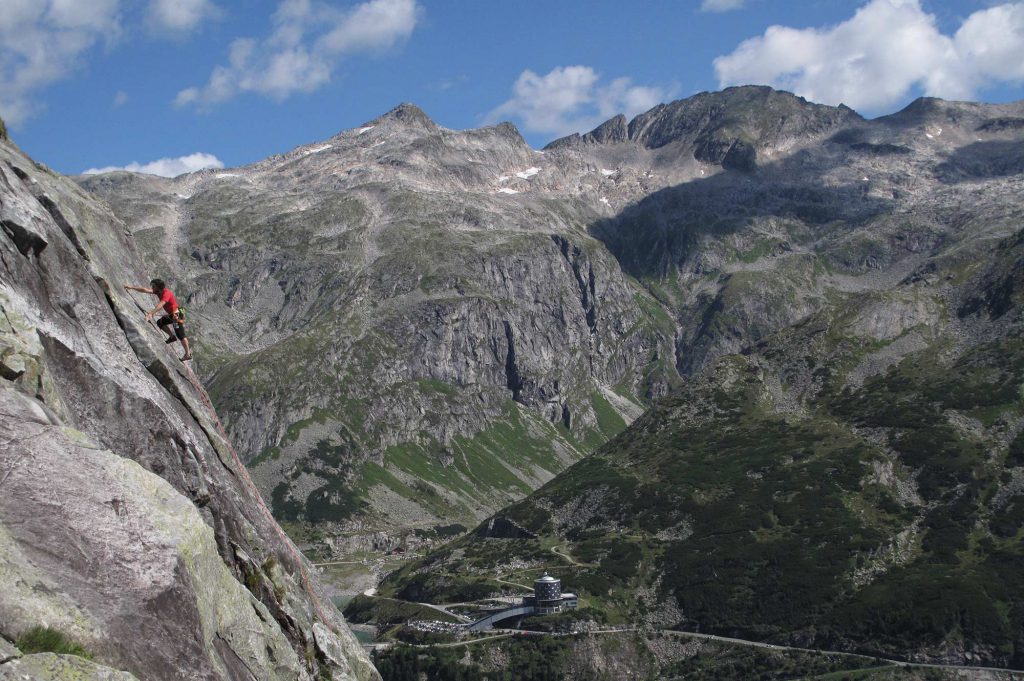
[388,227,1024,668]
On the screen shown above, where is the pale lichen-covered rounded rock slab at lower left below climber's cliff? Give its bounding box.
[0,385,309,679]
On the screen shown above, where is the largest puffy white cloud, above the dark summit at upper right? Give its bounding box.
[715,0,1024,112]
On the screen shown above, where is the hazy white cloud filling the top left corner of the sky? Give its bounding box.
[0,0,121,127]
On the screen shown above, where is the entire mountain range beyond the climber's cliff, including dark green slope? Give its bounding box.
[58,87,1024,668]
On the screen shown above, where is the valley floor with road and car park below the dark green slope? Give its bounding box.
[316,546,1024,681]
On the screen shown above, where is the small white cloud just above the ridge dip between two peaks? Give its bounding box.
[485,66,675,135]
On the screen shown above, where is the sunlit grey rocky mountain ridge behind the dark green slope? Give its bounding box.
[82,87,1021,561]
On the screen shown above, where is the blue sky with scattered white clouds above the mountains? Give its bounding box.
[0,0,1024,174]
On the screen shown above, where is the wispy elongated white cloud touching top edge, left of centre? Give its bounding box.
[174,0,422,107]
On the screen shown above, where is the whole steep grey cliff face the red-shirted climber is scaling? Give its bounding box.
[0,141,378,680]
